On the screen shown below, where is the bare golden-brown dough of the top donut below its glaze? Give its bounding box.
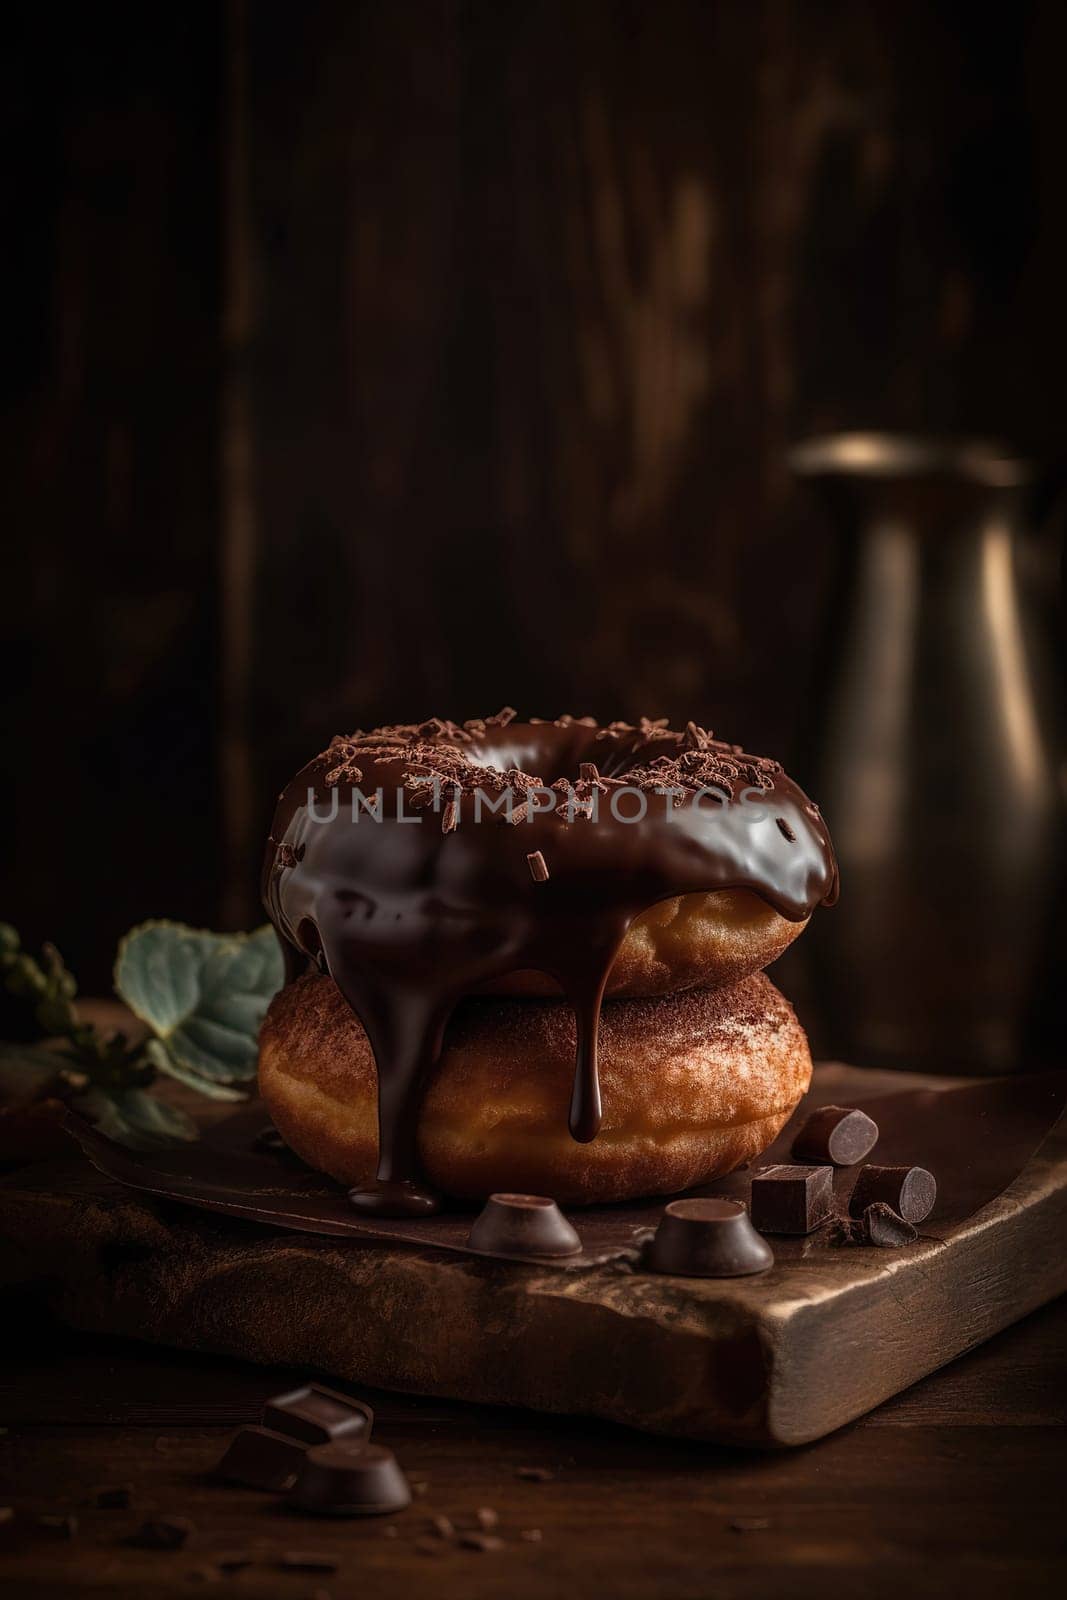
[480,890,808,1000]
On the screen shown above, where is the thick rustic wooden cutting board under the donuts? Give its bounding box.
[0,1066,1067,1445]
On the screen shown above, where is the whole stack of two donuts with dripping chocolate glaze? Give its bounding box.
[259,710,837,1213]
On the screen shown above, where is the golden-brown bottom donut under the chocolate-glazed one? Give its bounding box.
[259,973,811,1205]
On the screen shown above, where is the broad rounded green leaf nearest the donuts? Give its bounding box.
[115,922,283,1088]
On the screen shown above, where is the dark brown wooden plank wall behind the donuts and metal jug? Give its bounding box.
[0,0,1067,987]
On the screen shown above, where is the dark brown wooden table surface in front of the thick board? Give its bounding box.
[0,1301,1067,1600]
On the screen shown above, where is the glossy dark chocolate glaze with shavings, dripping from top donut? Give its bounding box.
[264,709,837,1214]
